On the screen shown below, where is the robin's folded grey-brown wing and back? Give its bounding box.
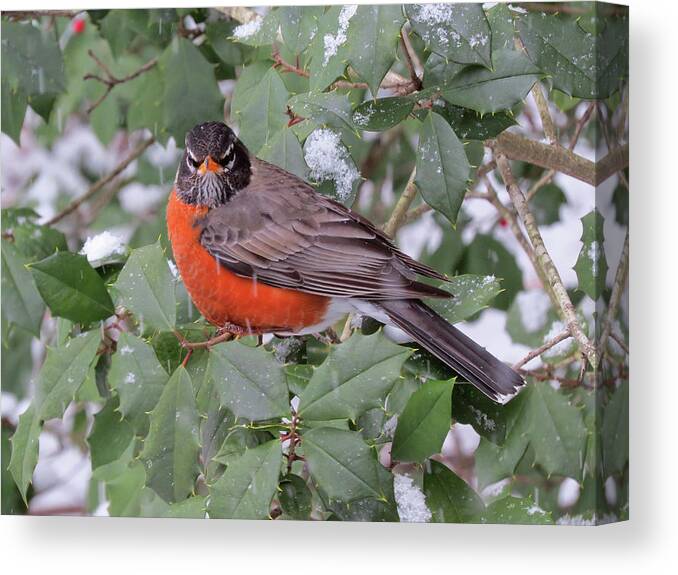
[199,159,450,300]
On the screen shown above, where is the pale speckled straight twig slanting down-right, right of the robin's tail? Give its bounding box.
[495,152,598,367]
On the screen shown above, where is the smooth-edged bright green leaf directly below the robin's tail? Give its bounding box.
[391,379,454,461]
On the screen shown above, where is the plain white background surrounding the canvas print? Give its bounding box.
[0,0,678,575]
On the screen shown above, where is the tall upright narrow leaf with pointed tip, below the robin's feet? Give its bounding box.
[140,367,200,502]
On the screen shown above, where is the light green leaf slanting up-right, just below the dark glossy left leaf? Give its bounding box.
[33,330,101,420]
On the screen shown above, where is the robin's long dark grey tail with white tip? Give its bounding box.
[374,300,525,403]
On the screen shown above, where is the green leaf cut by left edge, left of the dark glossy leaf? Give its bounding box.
[2,239,45,337]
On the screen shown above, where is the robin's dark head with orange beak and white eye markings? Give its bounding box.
[175,122,251,208]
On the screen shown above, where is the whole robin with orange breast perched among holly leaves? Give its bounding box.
[166,122,525,403]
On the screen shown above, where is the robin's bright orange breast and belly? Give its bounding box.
[167,190,329,332]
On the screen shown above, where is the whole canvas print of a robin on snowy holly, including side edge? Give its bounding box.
[1,2,629,525]
